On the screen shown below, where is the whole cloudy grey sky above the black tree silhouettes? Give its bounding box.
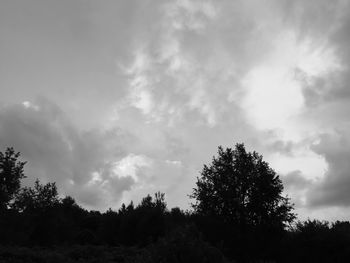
[0,0,350,220]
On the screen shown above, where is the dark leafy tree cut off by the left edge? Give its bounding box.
[0,147,26,210]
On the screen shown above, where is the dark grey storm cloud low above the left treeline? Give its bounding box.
[0,99,134,210]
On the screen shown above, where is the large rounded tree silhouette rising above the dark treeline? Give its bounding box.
[190,144,295,230]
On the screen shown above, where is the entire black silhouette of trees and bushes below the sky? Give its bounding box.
[0,144,350,263]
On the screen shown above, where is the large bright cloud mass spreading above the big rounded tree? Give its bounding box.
[113,1,343,214]
